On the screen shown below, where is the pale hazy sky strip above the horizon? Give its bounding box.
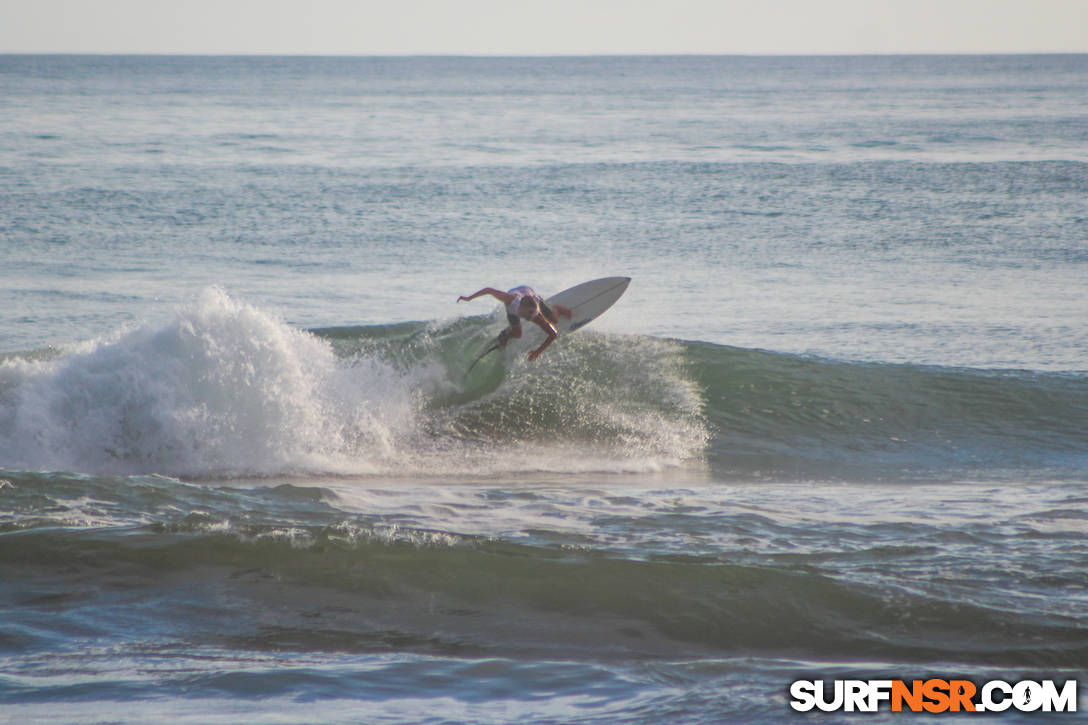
[0,0,1088,56]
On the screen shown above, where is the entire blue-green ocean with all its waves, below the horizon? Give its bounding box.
[0,56,1088,724]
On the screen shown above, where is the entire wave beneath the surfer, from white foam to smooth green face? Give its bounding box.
[0,290,1088,479]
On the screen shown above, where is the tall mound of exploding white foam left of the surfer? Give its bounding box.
[0,288,411,476]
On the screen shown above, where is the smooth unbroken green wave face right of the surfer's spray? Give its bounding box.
[688,343,1088,478]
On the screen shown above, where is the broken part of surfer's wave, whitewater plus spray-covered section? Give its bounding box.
[0,290,706,477]
